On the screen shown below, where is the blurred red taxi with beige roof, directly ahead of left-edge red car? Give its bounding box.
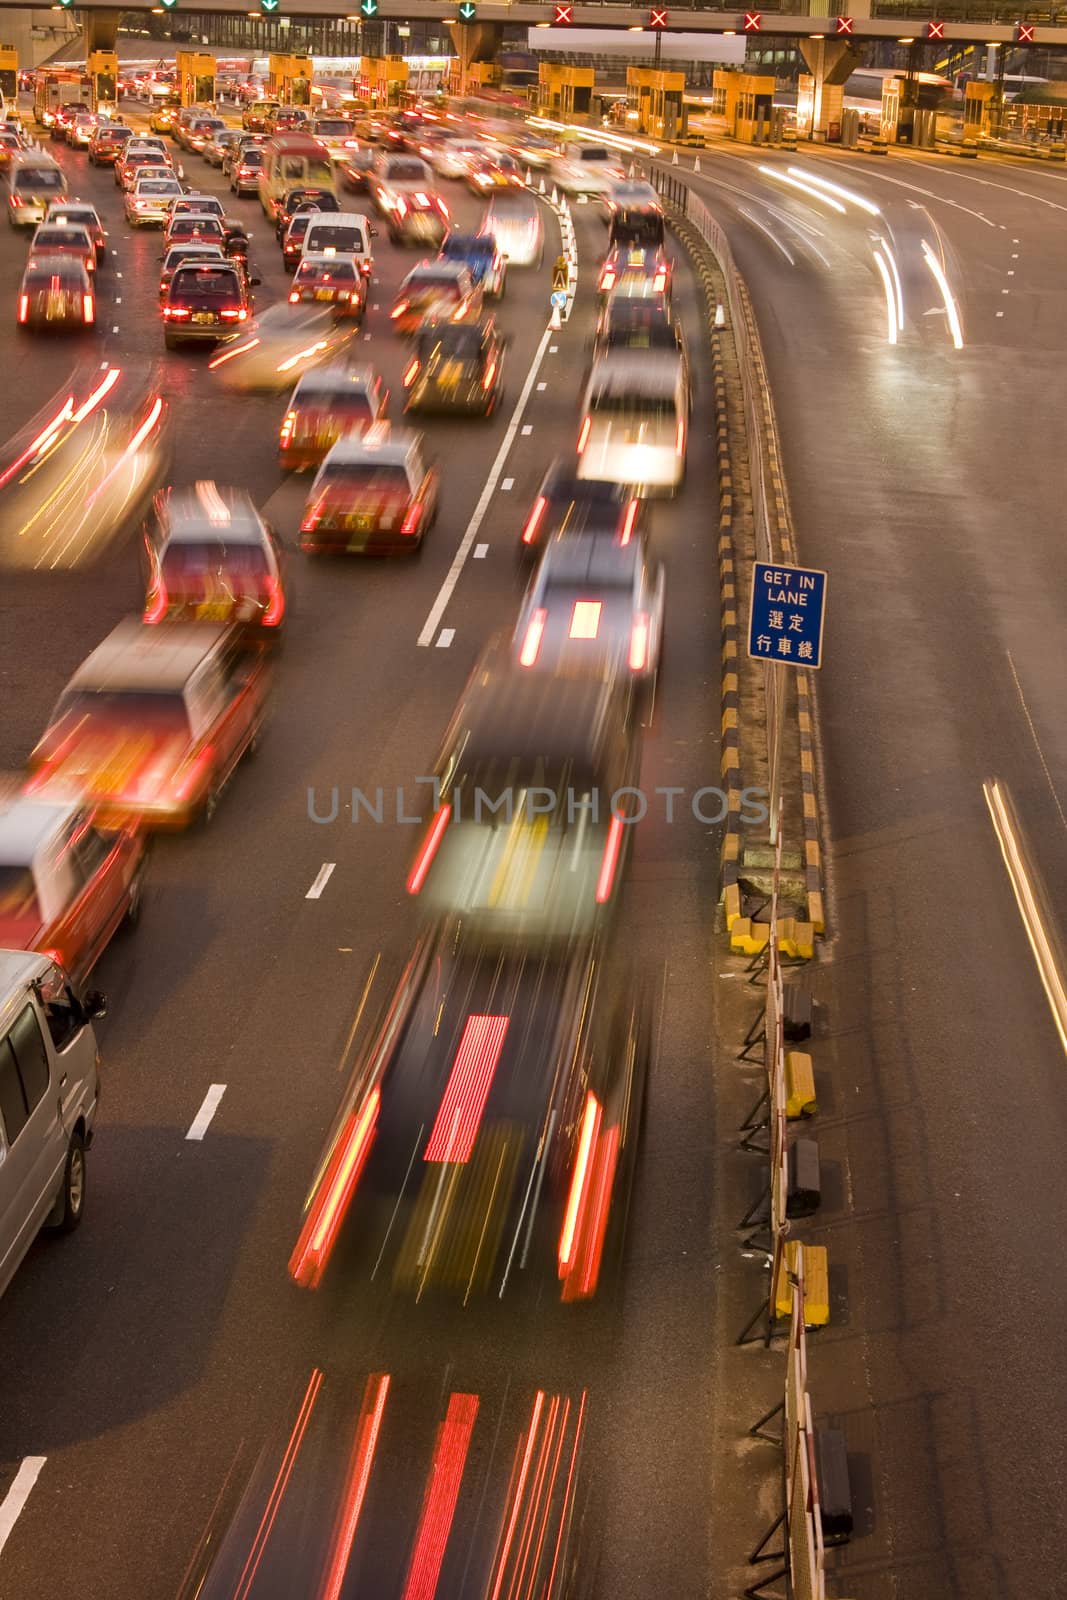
[27,618,270,829]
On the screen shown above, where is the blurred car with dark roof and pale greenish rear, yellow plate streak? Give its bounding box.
[406,638,640,950]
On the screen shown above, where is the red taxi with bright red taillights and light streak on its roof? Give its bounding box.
[142,482,285,640]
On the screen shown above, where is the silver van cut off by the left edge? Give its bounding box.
[0,950,106,1294]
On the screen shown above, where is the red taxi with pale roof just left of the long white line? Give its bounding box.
[301,422,438,555]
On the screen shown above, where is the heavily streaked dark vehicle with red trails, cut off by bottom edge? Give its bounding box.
[179,1369,603,1600]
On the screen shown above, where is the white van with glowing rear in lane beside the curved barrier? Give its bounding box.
[577,350,689,496]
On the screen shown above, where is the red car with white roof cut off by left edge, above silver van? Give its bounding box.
[0,794,144,986]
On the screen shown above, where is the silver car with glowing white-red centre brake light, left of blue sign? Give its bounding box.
[512,533,665,680]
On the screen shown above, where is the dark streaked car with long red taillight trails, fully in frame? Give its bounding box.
[290,923,653,1305]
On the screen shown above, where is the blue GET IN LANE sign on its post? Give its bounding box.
[749,562,825,845]
